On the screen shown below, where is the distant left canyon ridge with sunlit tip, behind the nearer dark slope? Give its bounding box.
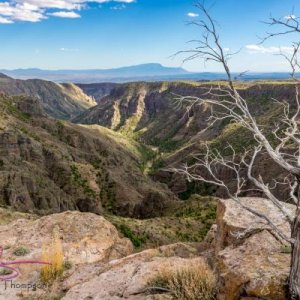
[0,75,96,119]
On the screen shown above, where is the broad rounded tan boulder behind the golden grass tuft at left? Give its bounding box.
[0,211,133,264]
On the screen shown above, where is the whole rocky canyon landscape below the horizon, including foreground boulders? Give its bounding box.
[0,75,294,300]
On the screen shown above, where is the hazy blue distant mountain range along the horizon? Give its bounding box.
[0,63,296,83]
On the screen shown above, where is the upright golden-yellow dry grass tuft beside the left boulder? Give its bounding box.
[40,231,64,284]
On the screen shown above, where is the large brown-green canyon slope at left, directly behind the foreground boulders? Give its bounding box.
[0,95,176,217]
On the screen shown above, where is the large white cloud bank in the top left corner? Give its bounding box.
[0,0,135,24]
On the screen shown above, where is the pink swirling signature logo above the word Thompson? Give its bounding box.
[0,246,51,281]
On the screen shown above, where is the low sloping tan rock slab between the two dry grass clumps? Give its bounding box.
[63,244,205,300]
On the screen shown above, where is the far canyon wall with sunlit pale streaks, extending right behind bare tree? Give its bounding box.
[73,82,295,199]
